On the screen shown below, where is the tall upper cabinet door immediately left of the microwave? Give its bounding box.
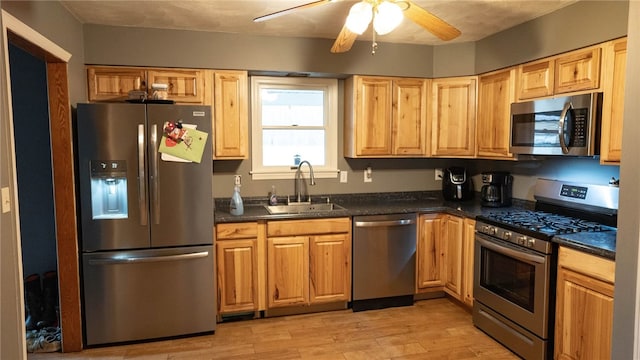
[476,68,515,158]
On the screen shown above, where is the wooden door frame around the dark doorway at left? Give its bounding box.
[1,10,82,356]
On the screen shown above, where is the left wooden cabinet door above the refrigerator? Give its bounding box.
[87,66,147,101]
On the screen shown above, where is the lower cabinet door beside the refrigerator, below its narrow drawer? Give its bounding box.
[216,239,258,314]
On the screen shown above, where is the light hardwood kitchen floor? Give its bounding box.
[29,298,518,360]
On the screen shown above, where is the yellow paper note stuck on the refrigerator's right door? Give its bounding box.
[158,124,209,163]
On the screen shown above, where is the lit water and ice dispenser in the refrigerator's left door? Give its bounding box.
[91,160,129,220]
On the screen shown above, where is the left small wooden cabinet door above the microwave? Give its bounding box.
[517,59,554,100]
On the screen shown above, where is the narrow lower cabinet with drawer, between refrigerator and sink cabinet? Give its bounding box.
[216,222,266,315]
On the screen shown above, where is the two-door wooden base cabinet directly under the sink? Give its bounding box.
[267,218,351,308]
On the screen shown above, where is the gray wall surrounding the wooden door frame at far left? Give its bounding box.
[0,0,86,359]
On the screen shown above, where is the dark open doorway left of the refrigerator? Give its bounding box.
[9,43,61,352]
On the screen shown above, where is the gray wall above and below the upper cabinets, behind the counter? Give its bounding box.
[79,1,628,199]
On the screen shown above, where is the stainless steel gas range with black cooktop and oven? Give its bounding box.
[473,179,618,359]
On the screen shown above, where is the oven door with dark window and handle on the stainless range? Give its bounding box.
[473,233,554,339]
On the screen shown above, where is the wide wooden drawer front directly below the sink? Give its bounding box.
[267,218,351,237]
